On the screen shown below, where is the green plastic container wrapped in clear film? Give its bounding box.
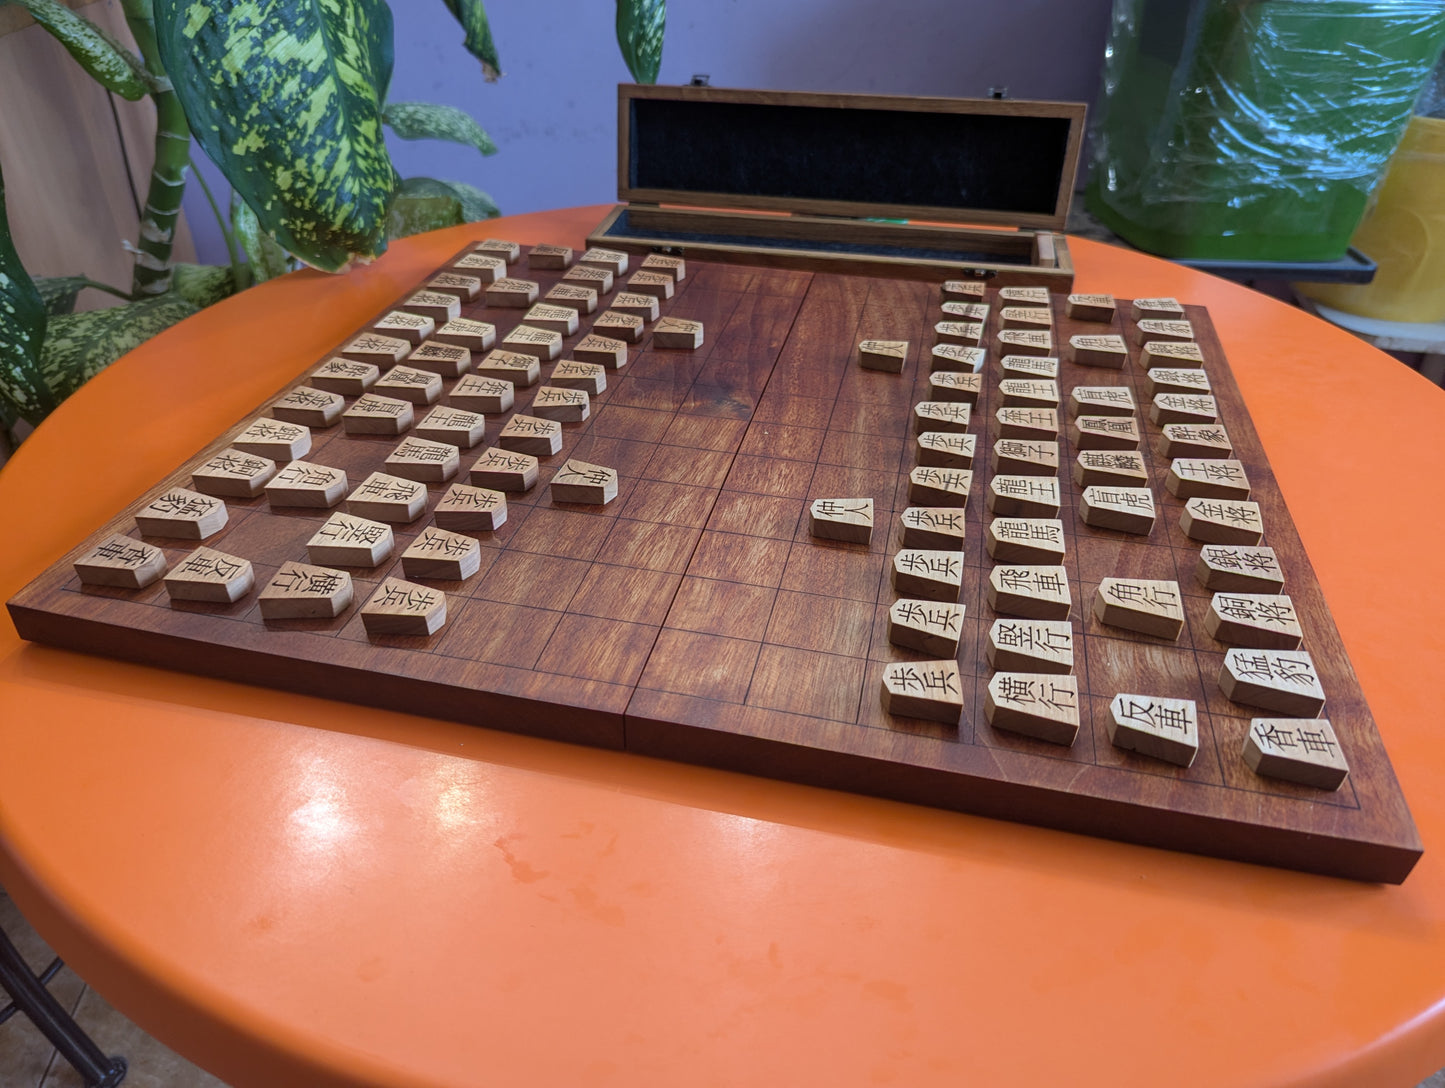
[1085,0,1445,260]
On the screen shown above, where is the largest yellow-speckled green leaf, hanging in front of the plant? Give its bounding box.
[155,0,396,272]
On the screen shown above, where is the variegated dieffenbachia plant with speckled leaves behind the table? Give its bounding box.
[0,0,666,442]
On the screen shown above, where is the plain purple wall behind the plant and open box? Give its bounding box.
[185,0,1111,263]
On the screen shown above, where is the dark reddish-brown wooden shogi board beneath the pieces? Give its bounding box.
[10,244,1420,881]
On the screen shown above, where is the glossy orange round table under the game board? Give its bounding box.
[0,208,1445,1088]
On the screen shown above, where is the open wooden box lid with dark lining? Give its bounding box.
[617,84,1084,230]
